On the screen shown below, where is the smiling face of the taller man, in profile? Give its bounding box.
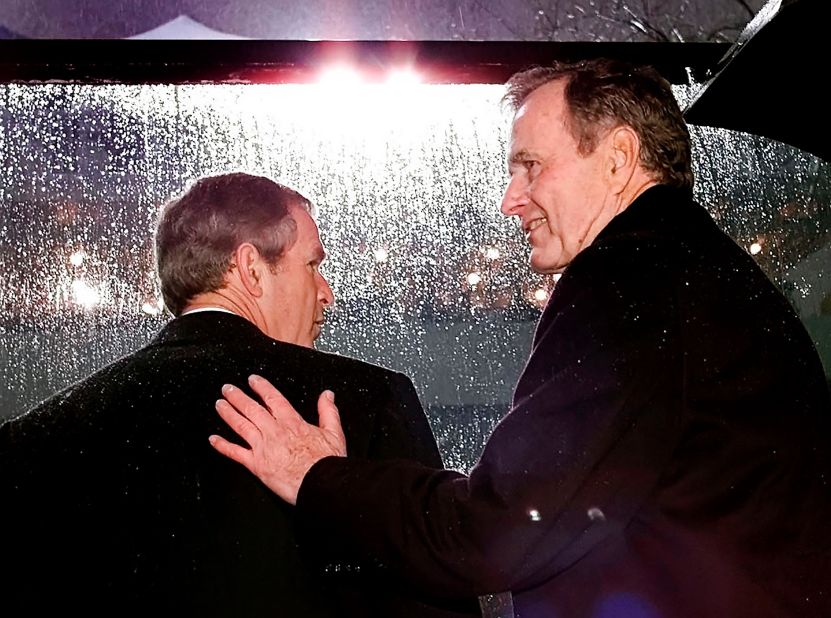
[502,80,614,273]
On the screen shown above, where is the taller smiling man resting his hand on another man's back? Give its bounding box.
[211,60,831,618]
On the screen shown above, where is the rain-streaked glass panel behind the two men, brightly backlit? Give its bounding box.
[0,84,831,470]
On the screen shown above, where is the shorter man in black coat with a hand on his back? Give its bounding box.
[0,173,476,618]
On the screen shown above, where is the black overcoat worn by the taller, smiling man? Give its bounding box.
[298,186,831,618]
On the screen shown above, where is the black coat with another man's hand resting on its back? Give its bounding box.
[0,312,478,618]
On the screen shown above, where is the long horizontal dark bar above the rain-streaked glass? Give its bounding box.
[0,39,729,84]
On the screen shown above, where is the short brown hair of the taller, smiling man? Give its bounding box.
[504,58,694,191]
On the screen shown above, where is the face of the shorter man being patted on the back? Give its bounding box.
[263,207,334,348]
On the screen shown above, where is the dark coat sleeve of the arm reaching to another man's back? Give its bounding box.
[297,239,683,596]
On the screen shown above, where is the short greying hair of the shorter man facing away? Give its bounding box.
[156,172,312,315]
